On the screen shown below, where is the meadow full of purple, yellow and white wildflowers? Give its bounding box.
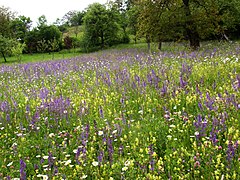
[0,45,240,180]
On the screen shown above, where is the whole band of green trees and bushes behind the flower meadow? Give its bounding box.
[0,0,240,61]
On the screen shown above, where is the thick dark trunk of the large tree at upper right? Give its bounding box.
[183,0,200,50]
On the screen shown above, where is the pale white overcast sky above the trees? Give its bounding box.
[0,0,107,26]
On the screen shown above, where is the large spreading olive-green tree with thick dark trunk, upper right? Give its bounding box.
[134,0,240,50]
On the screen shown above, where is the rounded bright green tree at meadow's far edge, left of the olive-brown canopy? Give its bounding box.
[83,3,119,48]
